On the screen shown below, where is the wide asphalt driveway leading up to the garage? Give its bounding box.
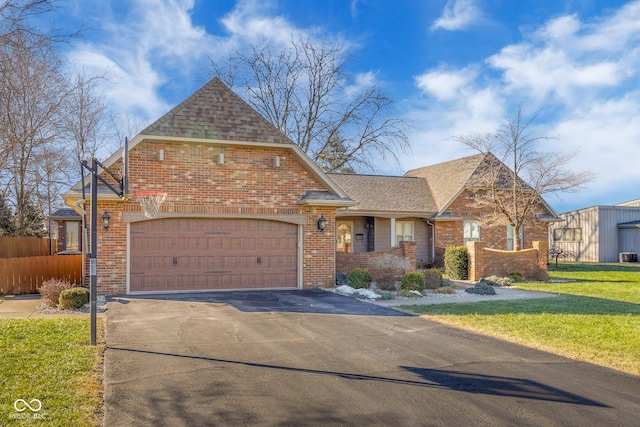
[105,290,640,426]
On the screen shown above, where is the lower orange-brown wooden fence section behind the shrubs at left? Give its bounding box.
[0,254,82,295]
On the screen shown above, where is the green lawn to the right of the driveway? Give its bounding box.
[403,263,640,375]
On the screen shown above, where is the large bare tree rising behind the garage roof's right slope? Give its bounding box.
[211,34,409,172]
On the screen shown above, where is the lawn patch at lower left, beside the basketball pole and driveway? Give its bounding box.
[0,318,104,427]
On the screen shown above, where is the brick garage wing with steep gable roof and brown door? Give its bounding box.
[63,79,356,295]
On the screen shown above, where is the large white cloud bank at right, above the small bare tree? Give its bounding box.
[402,1,640,211]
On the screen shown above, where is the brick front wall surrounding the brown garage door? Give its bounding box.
[87,140,335,294]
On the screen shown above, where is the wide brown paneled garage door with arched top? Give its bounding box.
[130,218,298,292]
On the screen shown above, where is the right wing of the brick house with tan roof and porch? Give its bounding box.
[329,154,558,265]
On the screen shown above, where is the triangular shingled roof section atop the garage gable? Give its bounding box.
[140,77,293,144]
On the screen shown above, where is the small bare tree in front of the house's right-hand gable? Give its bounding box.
[453,107,593,250]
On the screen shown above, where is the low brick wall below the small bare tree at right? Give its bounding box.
[467,241,549,281]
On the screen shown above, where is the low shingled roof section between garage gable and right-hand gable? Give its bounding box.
[328,173,437,216]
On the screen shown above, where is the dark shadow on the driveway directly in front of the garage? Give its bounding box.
[109,289,413,316]
